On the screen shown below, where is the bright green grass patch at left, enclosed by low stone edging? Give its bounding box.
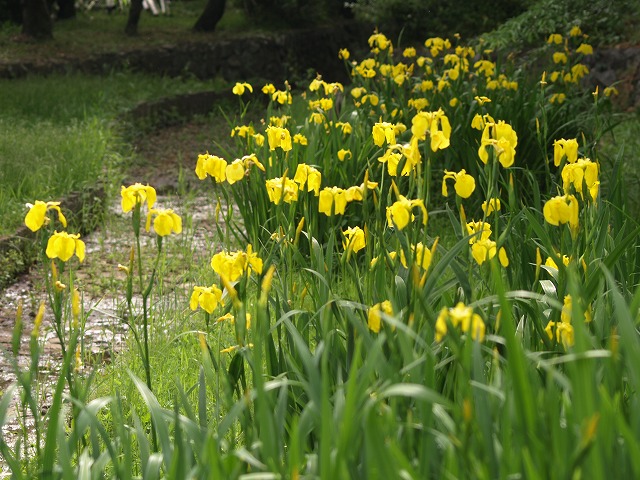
[0,72,230,235]
